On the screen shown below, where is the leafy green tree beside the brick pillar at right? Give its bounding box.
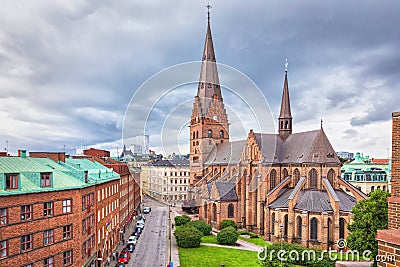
[347,189,389,264]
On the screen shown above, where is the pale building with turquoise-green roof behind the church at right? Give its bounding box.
[341,152,391,194]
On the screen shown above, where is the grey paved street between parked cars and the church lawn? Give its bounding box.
[127,198,168,267]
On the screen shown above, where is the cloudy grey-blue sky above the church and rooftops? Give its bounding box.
[0,0,400,157]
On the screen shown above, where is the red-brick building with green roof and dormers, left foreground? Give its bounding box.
[0,152,130,267]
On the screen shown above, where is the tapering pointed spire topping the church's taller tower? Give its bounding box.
[197,4,222,115]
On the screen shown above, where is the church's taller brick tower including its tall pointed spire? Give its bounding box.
[190,8,229,186]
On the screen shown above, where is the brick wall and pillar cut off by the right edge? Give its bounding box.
[376,112,400,267]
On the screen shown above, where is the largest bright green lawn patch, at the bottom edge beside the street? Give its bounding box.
[179,246,260,267]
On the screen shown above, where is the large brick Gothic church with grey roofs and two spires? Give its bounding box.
[189,11,367,249]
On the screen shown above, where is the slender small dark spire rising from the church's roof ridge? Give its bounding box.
[278,59,293,139]
